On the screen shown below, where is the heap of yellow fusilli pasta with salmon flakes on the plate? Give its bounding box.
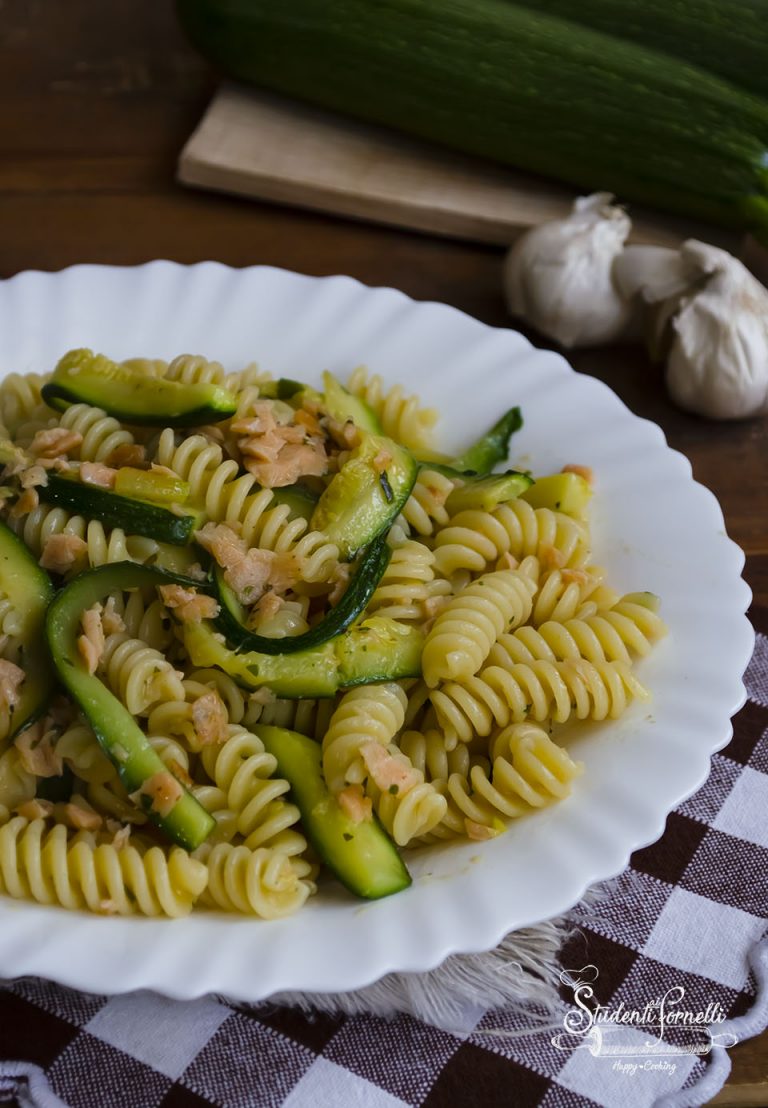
[0,351,665,920]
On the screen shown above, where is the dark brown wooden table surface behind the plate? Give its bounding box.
[0,0,768,1105]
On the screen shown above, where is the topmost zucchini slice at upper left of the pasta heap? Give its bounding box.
[42,349,237,427]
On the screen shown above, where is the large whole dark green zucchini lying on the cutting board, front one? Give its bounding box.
[177,0,768,237]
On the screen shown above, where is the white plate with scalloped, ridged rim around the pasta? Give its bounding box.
[0,261,754,1001]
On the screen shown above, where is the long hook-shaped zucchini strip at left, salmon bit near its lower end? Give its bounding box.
[45,562,216,850]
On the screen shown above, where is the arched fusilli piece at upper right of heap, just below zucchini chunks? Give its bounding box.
[434,500,590,577]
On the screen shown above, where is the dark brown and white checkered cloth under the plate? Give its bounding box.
[0,612,768,1108]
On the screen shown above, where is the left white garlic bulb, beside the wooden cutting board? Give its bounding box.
[504,193,634,347]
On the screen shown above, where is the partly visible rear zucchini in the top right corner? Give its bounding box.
[516,0,768,99]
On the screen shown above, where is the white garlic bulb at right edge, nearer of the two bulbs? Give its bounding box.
[666,239,768,419]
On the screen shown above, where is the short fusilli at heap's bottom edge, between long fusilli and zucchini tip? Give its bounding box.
[197,842,315,920]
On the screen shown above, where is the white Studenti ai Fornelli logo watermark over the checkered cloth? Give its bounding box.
[552,965,737,1063]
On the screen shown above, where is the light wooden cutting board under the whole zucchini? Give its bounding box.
[178,84,739,252]
